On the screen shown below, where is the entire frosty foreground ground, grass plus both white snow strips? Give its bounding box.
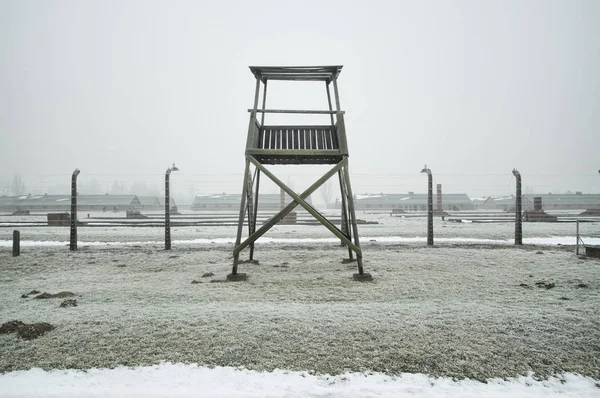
[0,211,600,397]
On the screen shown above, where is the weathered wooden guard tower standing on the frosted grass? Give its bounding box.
[227,65,371,281]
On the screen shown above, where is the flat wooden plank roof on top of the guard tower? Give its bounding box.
[250,65,342,83]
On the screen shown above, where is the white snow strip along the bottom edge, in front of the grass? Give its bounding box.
[0,363,600,398]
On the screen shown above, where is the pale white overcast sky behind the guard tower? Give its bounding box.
[0,0,600,199]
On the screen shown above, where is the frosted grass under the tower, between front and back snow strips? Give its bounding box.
[0,242,600,380]
